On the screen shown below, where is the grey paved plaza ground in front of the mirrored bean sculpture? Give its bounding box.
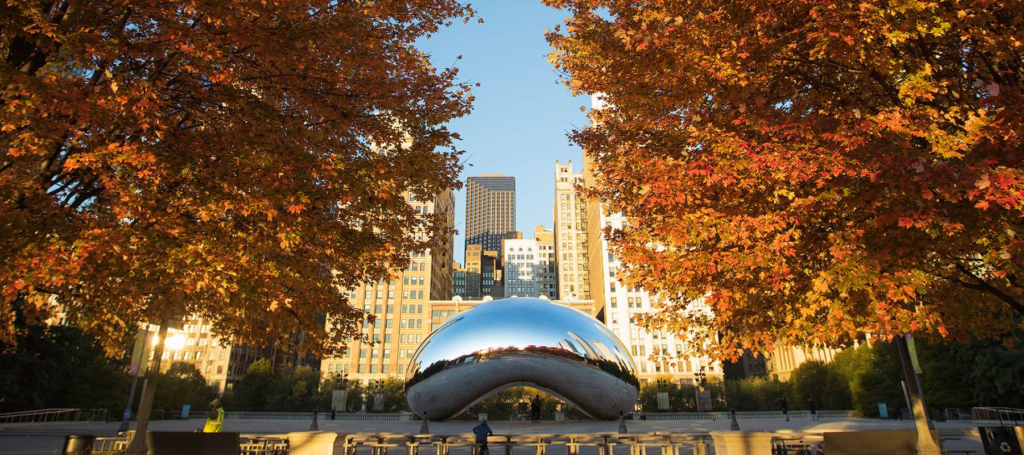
[0,419,982,455]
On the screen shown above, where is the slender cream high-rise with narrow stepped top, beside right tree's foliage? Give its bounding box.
[554,161,591,300]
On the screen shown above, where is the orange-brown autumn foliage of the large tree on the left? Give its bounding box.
[0,0,473,355]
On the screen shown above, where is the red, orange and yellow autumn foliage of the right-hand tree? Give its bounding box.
[545,0,1024,358]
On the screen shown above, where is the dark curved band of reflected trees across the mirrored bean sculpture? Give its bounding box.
[407,345,640,389]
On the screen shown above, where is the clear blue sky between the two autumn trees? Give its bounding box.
[420,0,590,262]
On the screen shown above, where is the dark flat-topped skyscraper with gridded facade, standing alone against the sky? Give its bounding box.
[466,174,515,256]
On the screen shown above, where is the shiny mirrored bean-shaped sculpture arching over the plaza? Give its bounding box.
[406,298,640,420]
